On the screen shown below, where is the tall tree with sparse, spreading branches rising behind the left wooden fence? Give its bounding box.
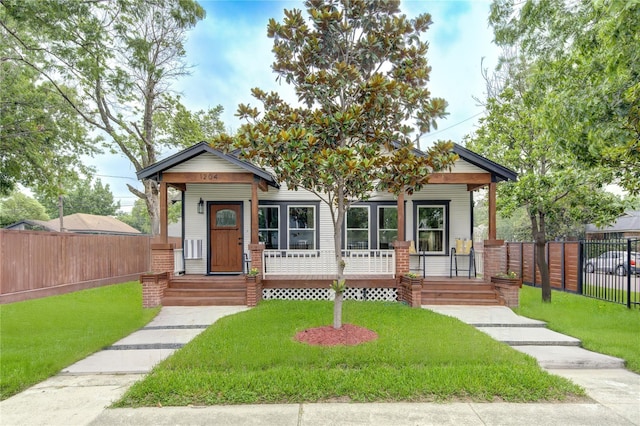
[0,0,221,234]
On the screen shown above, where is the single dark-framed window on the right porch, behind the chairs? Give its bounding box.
[417,205,447,254]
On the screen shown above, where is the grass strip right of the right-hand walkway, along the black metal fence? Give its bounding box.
[515,286,640,373]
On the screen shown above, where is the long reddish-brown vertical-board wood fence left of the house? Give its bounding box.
[0,229,157,303]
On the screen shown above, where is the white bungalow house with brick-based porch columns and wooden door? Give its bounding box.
[137,142,517,305]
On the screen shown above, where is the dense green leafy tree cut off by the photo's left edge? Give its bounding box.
[0,47,95,195]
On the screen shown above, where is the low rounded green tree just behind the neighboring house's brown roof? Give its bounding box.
[36,178,120,218]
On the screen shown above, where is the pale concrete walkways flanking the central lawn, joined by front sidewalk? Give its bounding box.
[0,306,640,426]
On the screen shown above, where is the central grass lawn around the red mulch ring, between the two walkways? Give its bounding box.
[115,300,584,407]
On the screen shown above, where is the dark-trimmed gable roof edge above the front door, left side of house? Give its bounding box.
[136,141,280,188]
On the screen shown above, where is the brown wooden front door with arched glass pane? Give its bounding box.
[209,203,242,273]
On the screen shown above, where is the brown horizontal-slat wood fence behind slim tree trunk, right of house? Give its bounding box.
[507,241,581,292]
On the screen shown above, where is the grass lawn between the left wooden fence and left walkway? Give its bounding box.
[0,282,159,399]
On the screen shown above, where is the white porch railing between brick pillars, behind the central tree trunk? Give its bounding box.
[262,250,396,277]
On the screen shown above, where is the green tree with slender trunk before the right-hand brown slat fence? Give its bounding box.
[467,55,624,302]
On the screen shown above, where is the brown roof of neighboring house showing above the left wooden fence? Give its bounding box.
[5,213,140,235]
